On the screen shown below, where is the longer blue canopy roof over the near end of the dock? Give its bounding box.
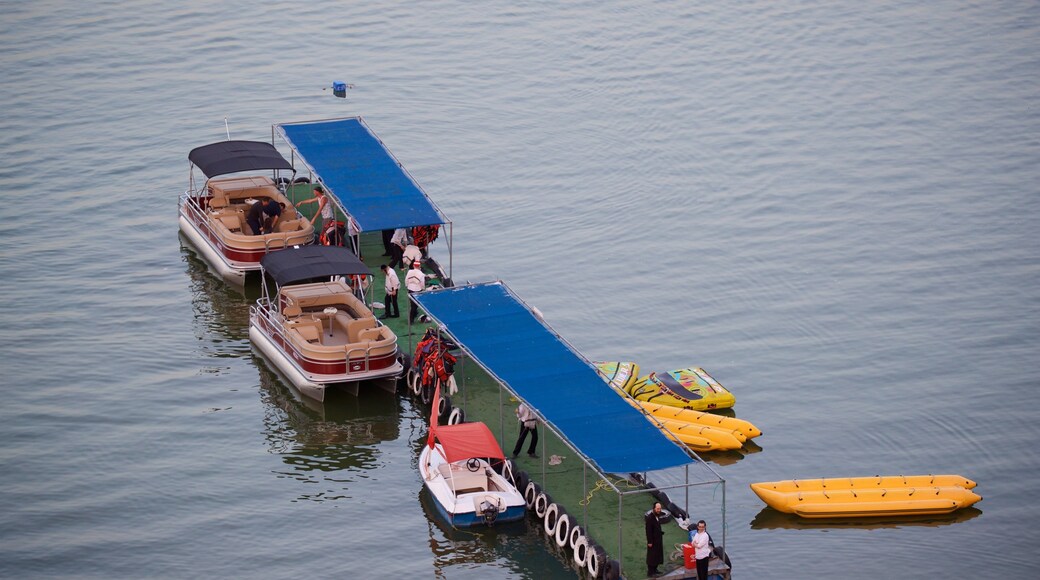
[412,282,693,473]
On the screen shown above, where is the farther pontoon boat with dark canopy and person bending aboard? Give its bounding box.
[178,140,314,285]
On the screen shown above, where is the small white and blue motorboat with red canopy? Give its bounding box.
[419,385,527,528]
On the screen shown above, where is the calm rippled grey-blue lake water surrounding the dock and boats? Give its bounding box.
[0,0,1040,580]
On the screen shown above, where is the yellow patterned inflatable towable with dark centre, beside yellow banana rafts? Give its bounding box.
[627,367,736,411]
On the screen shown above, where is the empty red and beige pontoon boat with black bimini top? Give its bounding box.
[250,245,404,401]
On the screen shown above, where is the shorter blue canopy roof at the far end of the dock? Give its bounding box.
[275,117,447,232]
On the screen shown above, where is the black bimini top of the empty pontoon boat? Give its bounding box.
[260,245,369,286]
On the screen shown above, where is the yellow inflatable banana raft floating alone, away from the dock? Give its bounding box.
[751,475,982,518]
